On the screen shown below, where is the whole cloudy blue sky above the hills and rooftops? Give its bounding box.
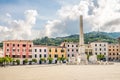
[0,0,120,41]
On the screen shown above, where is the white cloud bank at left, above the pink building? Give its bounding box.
[0,10,38,40]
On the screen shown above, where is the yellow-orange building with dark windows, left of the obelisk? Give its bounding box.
[48,46,66,59]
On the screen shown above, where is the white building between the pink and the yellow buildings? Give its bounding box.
[32,45,48,63]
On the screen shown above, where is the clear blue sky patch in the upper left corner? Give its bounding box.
[0,0,60,28]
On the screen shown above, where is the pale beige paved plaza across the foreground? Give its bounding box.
[0,63,120,80]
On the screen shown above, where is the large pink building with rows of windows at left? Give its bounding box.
[3,40,33,59]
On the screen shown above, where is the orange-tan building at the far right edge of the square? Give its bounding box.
[108,44,120,61]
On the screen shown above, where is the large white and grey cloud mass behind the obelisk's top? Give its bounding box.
[43,0,120,36]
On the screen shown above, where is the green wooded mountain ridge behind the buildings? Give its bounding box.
[33,32,120,46]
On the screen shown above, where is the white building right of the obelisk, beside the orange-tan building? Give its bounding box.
[90,42,108,60]
